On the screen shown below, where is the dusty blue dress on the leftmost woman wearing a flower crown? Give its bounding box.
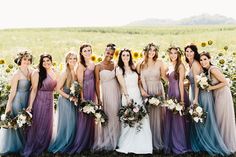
[0,79,31,155]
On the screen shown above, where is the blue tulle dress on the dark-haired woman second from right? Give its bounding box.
[189,72,230,156]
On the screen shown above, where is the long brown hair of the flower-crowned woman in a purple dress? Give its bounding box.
[167,46,182,80]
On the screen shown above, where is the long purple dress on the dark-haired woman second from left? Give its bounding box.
[23,75,57,157]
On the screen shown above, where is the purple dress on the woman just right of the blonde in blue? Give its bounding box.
[68,68,96,154]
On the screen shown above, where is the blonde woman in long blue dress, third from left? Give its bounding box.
[48,52,77,153]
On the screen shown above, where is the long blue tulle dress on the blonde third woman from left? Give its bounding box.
[48,87,76,153]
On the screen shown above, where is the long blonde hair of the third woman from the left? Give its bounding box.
[65,51,78,87]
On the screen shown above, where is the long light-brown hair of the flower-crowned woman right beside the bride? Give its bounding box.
[140,43,159,69]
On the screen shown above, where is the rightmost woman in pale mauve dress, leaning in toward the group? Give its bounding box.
[200,52,236,153]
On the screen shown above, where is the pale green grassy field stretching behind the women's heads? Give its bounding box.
[0,25,236,62]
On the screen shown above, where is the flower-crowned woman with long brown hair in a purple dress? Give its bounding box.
[164,47,190,154]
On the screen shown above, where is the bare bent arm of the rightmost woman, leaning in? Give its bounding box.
[208,68,228,90]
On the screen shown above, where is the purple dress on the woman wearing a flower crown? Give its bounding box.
[164,71,190,154]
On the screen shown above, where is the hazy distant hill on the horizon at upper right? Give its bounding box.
[127,14,236,26]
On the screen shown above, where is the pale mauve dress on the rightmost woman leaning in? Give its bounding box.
[208,66,236,153]
